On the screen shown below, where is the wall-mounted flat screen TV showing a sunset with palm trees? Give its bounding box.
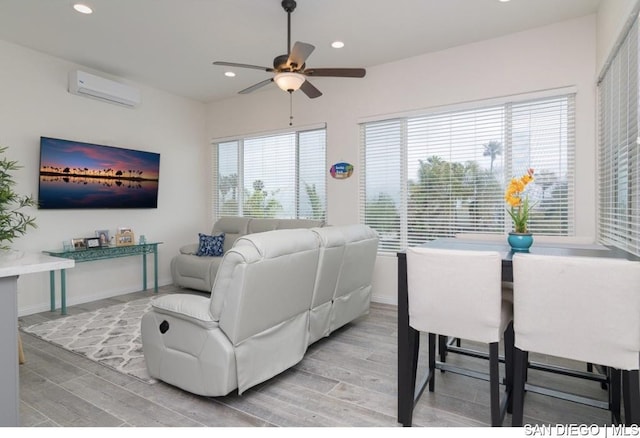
[38,137,160,209]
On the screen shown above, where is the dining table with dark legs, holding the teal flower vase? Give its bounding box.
[397,236,640,424]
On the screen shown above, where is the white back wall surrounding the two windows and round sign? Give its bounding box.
[207,15,596,303]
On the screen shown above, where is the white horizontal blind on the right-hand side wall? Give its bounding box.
[598,20,640,255]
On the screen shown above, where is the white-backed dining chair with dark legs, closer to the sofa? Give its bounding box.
[399,248,513,426]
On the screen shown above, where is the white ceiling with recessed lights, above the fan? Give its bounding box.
[0,0,610,102]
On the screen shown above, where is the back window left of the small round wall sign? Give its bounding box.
[214,128,326,219]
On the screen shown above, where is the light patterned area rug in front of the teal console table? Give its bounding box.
[20,297,156,384]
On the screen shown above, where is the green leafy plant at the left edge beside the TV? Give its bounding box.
[0,146,37,250]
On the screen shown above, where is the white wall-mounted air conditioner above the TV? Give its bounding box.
[69,70,140,107]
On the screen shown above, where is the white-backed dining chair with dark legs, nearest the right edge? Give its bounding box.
[512,254,640,426]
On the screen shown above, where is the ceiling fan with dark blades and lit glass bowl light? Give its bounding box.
[213,0,366,99]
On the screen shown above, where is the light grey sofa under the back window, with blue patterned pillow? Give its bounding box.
[171,216,324,292]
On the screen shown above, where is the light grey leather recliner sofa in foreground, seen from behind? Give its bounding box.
[141,225,378,396]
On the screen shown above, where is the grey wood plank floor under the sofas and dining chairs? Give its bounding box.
[19,286,609,427]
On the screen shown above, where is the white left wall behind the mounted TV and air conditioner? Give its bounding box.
[0,41,211,315]
